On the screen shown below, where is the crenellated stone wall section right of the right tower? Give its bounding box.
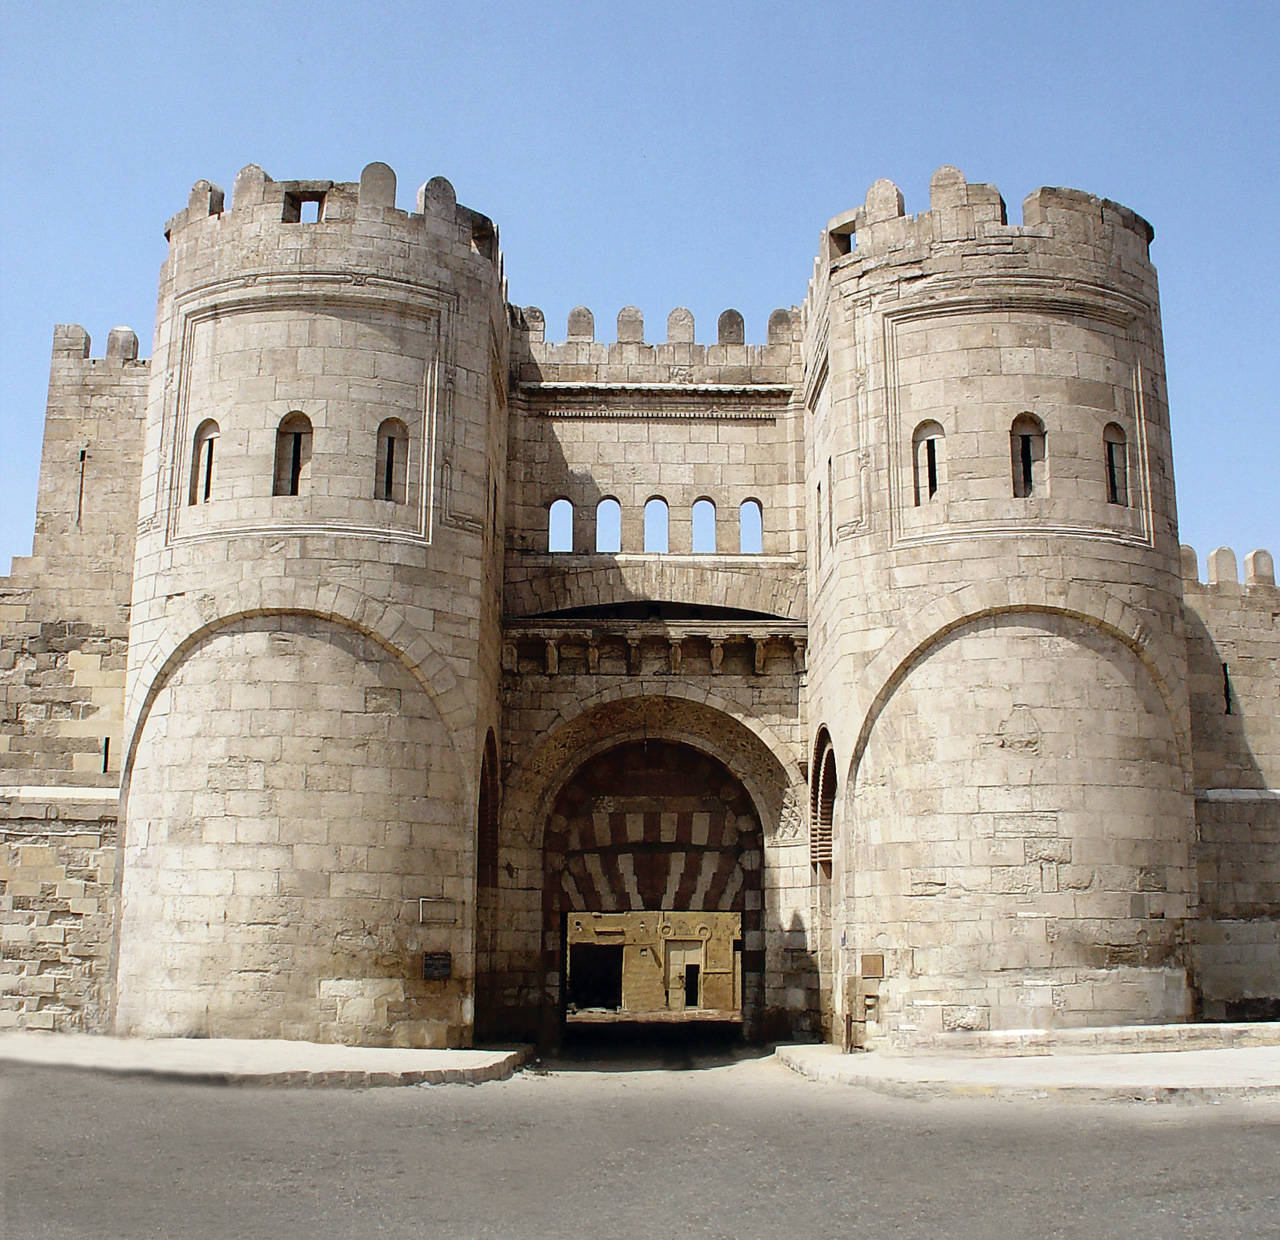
[1184,548,1280,1020]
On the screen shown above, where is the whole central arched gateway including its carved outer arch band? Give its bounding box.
[476,694,804,1044]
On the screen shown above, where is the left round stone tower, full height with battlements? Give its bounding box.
[116,164,506,1045]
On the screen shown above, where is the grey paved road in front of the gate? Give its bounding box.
[0,1051,1280,1240]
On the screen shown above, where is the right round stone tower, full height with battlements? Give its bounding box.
[805,168,1194,1044]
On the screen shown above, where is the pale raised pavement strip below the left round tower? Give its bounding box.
[0,1033,529,1089]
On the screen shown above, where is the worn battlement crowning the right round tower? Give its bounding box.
[820,166,1155,271]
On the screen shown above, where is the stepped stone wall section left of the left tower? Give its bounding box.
[0,325,148,1030]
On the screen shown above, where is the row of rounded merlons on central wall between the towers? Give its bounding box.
[511,306,799,384]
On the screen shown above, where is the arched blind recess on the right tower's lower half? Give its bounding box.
[841,607,1194,1042]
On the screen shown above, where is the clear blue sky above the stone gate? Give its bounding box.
[0,0,1280,571]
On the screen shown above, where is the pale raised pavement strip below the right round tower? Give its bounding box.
[774,1045,1280,1103]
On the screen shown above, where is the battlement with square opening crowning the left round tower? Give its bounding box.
[165,163,500,264]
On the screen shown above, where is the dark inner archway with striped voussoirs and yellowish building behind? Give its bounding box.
[543,740,764,1037]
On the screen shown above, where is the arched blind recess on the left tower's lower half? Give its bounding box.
[116,613,474,1045]
